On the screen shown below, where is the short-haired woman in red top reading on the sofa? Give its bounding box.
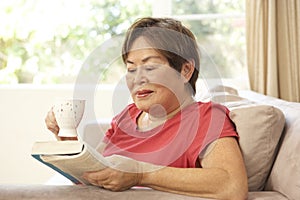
[45,18,248,200]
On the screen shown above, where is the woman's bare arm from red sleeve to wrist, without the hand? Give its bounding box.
[140,137,248,200]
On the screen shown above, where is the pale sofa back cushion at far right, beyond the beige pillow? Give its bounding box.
[248,94,300,200]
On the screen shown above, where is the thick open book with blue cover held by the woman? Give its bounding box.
[31,140,162,184]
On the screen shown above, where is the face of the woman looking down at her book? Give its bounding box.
[126,37,185,117]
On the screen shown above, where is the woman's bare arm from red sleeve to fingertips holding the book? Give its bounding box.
[84,137,248,200]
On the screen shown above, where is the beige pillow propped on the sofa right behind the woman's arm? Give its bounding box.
[229,105,285,191]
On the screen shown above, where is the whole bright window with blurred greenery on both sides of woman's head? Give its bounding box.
[0,0,247,87]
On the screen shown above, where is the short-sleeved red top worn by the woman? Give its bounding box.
[103,102,238,168]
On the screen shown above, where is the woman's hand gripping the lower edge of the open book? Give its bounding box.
[83,168,142,191]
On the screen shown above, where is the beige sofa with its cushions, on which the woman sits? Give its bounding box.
[0,87,300,200]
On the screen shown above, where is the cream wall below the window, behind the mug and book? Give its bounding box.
[0,85,129,184]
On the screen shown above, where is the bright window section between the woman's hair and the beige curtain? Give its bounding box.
[155,0,247,84]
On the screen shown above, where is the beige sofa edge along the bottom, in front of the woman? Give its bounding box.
[0,184,211,200]
